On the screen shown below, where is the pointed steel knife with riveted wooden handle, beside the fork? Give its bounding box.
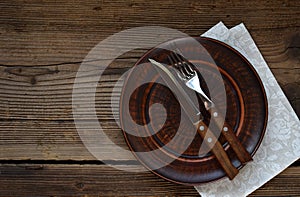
[149,59,238,180]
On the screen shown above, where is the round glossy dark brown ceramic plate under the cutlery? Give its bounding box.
[120,37,267,185]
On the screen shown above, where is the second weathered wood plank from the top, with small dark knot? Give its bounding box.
[0,63,300,120]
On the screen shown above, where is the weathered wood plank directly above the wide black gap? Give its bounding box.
[0,120,128,161]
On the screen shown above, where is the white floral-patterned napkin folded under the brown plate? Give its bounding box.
[195,22,300,197]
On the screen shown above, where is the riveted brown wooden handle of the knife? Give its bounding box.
[197,121,239,180]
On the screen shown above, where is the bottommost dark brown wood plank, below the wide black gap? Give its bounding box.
[0,164,300,196]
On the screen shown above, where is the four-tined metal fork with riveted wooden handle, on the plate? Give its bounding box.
[168,48,252,164]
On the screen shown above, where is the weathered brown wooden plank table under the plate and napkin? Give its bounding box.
[0,0,300,196]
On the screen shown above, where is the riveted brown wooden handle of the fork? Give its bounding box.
[209,107,253,164]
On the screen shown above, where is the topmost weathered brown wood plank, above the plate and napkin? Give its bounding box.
[0,1,299,65]
